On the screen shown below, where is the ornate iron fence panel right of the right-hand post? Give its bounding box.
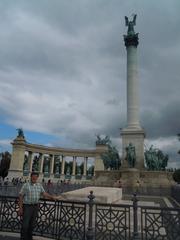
[141,207,180,240]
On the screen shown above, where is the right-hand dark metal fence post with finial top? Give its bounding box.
[132,193,139,240]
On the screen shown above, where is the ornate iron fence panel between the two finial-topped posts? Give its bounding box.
[95,204,130,240]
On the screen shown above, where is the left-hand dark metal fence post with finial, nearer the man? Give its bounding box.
[86,191,95,240]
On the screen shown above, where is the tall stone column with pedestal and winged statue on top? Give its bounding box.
[121,15,145,169]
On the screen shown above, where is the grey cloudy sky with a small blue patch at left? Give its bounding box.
[0,0,180,167]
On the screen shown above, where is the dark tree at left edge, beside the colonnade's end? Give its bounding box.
[0,151,11,179]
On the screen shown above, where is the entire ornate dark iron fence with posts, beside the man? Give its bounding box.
[0,192,180,240]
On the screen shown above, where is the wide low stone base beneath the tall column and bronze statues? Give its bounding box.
[94,168,175,196]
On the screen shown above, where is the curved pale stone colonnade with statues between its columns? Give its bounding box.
[8,136,107,180]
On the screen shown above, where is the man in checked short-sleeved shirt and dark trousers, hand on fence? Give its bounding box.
[19,172,60,240]
